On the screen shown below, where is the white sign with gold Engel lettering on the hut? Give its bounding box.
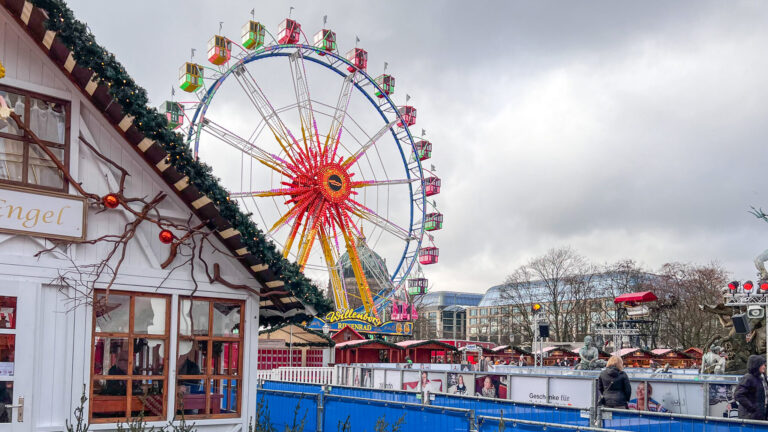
[0,185,87,240]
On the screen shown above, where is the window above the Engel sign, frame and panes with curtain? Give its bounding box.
[0,85,72,192]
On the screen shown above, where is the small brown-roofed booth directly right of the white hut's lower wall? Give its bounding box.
[259,324,336,370]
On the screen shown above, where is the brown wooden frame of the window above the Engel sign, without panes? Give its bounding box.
[0,84,72,193]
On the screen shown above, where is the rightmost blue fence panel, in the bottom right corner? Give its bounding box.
[601,409,768,432]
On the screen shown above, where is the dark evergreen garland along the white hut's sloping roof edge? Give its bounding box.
[31,0,331,322]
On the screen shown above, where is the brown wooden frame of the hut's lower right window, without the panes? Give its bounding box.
[174,296,246,419]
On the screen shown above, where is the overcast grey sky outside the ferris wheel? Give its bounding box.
[69,0,768,292]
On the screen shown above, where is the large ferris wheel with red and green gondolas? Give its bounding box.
[167,14,443,320]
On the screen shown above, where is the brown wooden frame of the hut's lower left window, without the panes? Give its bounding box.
[88,290,171,424]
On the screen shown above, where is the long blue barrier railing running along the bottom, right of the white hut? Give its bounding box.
[258,381,768,432]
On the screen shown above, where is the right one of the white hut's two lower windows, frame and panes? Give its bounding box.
[176,297,245,418]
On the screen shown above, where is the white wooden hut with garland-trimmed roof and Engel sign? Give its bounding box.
[0,0,331,432]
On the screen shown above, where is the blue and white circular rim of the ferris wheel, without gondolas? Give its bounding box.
[187,44,428,290]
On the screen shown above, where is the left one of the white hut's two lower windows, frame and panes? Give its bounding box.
[90,291,171,422]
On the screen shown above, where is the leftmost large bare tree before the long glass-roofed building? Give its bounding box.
[501,247,595,341]
